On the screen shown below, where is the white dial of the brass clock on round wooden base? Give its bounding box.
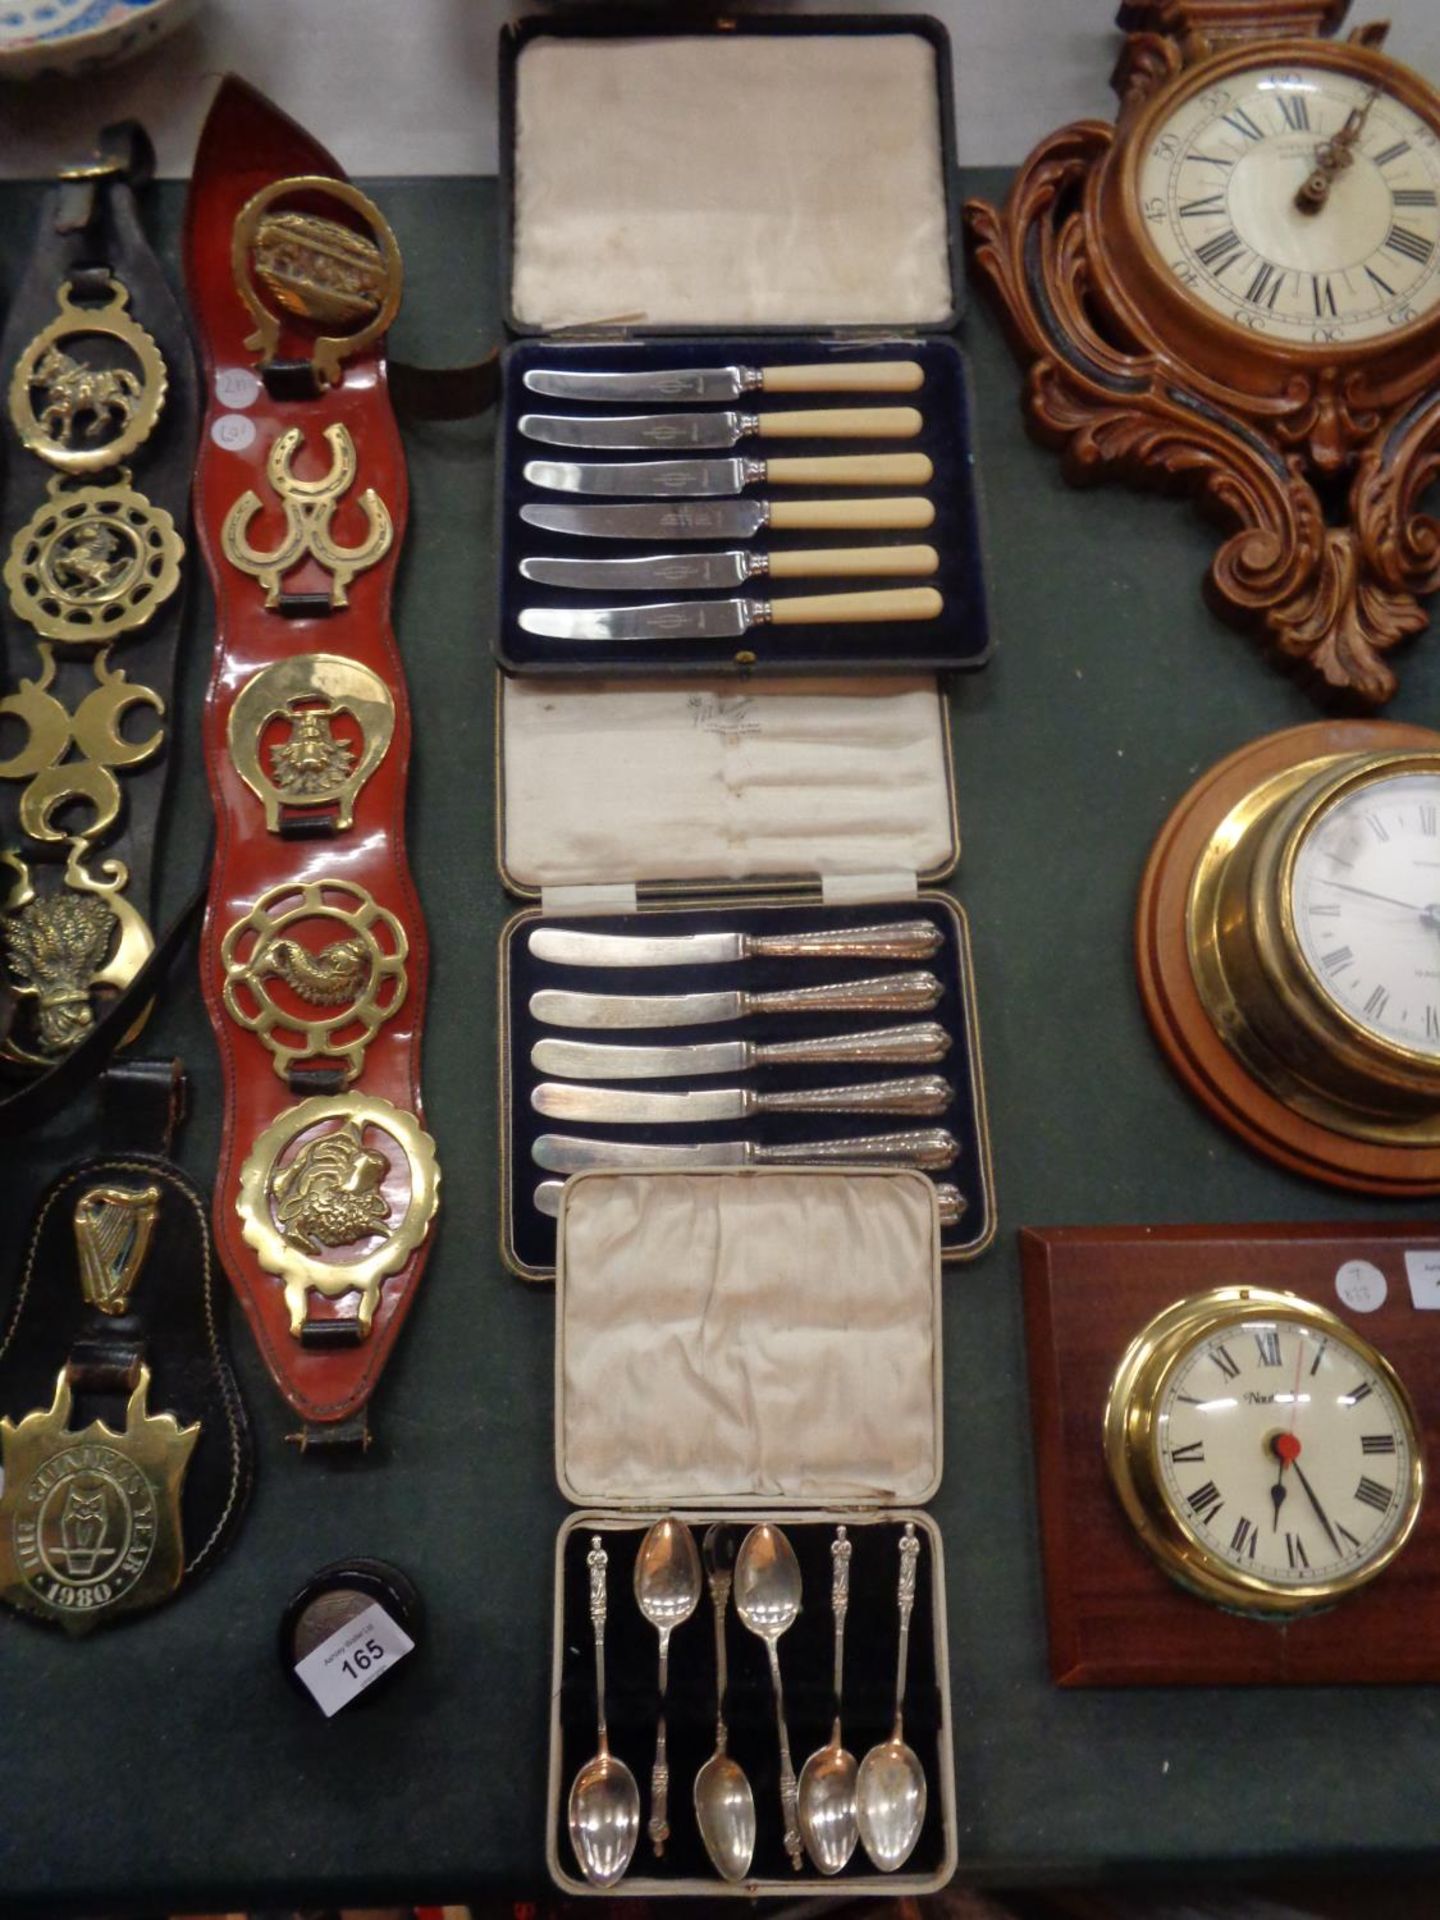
[1290,764,1440,1068]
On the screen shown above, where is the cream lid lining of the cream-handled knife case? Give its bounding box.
[513,33,954,332]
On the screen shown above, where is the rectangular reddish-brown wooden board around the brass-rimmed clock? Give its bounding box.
[1020,1219,1440,1688]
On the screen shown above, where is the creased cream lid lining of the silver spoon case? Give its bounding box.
[557,1169,941,1507]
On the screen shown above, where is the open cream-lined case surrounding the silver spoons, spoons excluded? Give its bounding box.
[547,1167,956,1897]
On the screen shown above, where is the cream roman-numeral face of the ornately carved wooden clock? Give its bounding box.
[1137,65,1440,348]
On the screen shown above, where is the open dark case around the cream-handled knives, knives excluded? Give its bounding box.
[493,8,989,676]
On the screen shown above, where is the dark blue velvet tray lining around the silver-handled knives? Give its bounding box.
[501,893,993,1275]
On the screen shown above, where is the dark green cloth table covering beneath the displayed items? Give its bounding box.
[0,173,1440,1912]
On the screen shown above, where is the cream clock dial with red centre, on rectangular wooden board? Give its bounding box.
[1152,1313,1419,1592]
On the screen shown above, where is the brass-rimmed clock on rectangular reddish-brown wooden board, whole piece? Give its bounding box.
[1020,1221,1440,1686]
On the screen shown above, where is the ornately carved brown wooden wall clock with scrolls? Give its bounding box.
[966,0,1440,705]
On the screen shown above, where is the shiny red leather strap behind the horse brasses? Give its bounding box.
[184,79,428,1423]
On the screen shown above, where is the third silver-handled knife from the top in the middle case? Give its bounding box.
[530,1020,950,1079]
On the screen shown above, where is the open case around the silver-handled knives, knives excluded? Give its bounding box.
[497,678,995,1281]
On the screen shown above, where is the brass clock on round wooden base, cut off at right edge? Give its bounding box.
[1137,720,1440,1194]
